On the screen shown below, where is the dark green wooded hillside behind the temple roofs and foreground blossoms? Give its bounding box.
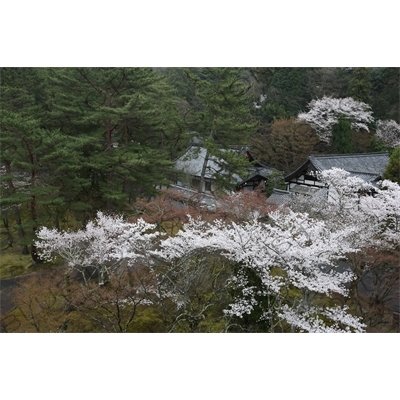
[0,68,400,253]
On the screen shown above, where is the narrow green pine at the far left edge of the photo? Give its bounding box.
[0,68,81,261]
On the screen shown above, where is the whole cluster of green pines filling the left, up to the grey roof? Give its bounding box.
[0,68,184,256]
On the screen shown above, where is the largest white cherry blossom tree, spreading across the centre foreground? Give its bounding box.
[153,211,363,332]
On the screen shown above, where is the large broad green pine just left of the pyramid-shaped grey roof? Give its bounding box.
[43,68,182,213]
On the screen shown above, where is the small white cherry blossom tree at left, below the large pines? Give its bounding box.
[35,212,160,285]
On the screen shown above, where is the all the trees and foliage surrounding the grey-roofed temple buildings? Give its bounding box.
[0,67,400,333]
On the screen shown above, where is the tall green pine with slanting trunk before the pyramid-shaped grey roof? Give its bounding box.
[185,68,256,192]
